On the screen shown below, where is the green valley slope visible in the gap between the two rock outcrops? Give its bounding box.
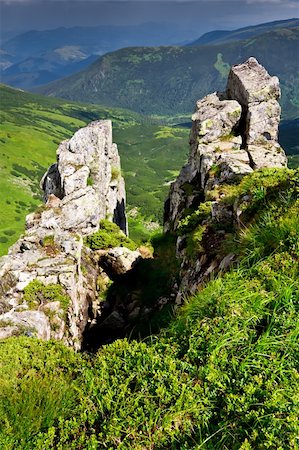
[114,124,189,225]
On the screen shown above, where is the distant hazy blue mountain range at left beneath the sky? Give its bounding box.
[0,23,192,89]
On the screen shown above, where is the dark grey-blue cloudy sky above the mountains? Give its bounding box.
[0,0,299,37]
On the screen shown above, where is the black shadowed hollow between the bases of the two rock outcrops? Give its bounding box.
[82,234,179,352]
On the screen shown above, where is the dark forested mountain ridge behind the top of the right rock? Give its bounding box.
[40,27,299,119]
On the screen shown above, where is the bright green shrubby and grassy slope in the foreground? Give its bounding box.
[0,169,299,450]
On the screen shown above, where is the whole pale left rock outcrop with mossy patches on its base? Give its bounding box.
[0,120,127,349]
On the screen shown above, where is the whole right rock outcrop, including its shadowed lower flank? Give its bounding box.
[164,58,287,302]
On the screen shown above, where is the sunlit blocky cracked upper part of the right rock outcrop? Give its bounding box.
[164,58,287,231]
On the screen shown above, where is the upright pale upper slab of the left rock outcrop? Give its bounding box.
[41,120,127,233]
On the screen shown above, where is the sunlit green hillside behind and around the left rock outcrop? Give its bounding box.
[0,86,188,254]
